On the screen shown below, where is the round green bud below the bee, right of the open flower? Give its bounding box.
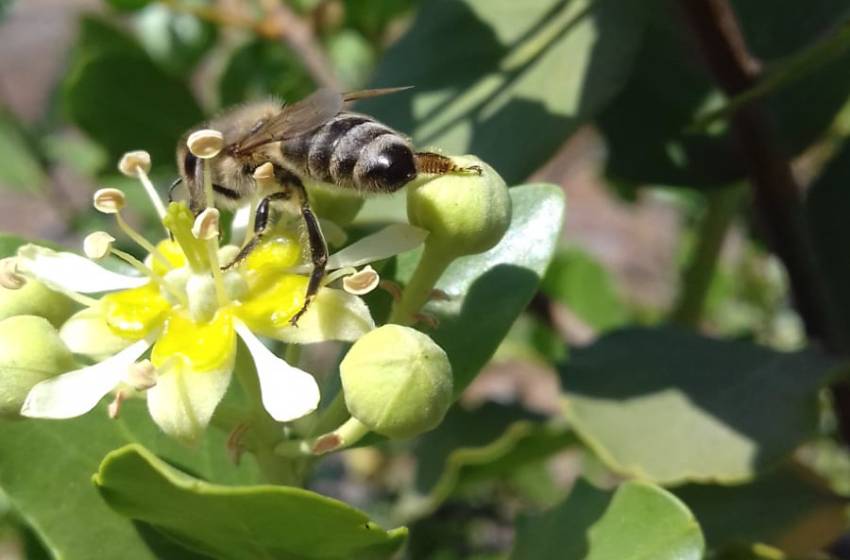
[339,325,452,438]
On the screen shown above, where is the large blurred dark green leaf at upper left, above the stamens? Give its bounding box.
[63,17,203,165]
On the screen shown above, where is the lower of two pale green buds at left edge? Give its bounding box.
[0,315,76,417]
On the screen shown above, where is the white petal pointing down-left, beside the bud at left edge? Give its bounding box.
[21,340,151,418]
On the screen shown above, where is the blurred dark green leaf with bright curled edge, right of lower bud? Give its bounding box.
[409,403,577,516]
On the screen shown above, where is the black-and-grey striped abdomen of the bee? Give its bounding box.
[281,112,416,192]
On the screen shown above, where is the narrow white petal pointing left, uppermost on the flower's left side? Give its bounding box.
[18,245,149,294]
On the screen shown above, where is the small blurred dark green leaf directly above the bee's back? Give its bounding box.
[218,39,315,107]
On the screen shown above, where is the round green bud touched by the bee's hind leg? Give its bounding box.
[407,156,511,257]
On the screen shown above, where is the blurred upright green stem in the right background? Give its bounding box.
[670,187,744,327]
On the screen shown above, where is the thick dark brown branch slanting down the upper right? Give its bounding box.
[679,0,846,352]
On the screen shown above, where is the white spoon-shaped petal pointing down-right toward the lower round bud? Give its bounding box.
[236,321,319,422]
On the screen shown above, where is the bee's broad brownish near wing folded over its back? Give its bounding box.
[237,88,344,151]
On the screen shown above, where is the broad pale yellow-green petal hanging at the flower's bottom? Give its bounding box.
[147,350,236,444]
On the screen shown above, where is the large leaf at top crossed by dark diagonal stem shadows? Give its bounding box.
[358,0,653,184]
